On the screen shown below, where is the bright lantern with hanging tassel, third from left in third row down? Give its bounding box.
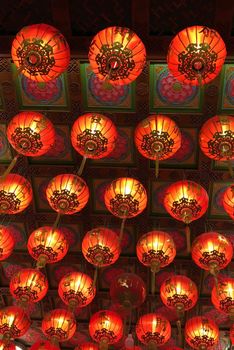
[104,177,147,241]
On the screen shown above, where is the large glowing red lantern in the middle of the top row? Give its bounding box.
[89,27,146,85]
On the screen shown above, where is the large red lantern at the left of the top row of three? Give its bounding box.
[11,23,70,83]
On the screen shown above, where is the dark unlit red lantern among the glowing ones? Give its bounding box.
[110,273,146,309]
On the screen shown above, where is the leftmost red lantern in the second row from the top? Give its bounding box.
[7,112,55,157]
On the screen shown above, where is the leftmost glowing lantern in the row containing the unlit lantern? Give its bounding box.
[10,269,48,303]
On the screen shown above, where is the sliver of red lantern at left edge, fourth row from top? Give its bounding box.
[0,225,15,261]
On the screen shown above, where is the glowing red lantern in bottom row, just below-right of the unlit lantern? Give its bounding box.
[136,313,171,347]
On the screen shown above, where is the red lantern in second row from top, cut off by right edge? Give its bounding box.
[199,115,234,161]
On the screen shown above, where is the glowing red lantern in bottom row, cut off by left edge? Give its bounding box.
[0,306,30,339]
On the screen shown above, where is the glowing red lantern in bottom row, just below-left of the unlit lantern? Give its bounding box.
[89,310,123,349]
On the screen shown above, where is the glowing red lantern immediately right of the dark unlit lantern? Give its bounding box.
[160,275,198,316]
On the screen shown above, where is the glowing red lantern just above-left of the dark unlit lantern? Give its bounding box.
[82,227,120,267]
